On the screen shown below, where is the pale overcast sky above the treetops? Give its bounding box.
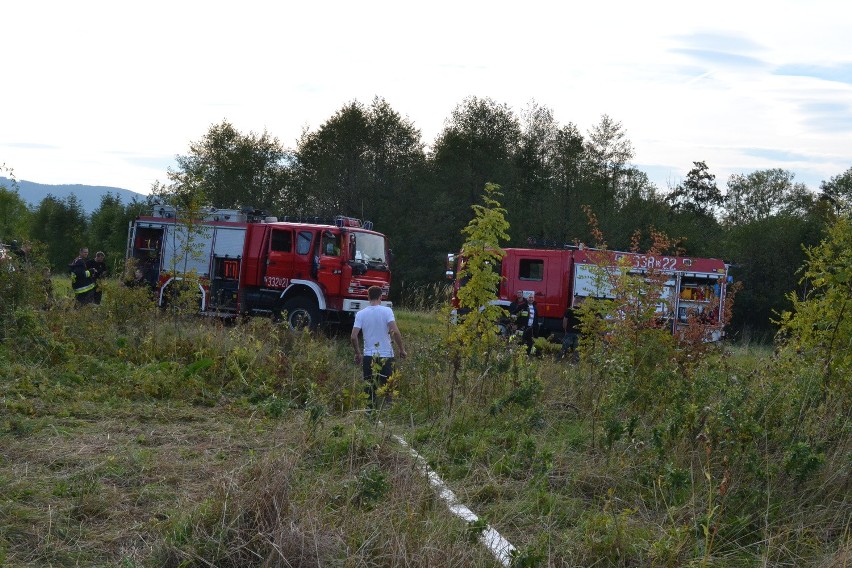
[0,0,852,193]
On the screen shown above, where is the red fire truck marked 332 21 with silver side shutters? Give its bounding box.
[127,205,391,327]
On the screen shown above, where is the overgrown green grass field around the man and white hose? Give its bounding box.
[0,282,852,567]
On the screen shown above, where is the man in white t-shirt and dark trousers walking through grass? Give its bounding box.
[350,286,408,408]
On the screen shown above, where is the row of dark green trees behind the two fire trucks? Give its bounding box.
[0,97,852,336]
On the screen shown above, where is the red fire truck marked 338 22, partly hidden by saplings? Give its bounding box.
[447,246,729,341]
